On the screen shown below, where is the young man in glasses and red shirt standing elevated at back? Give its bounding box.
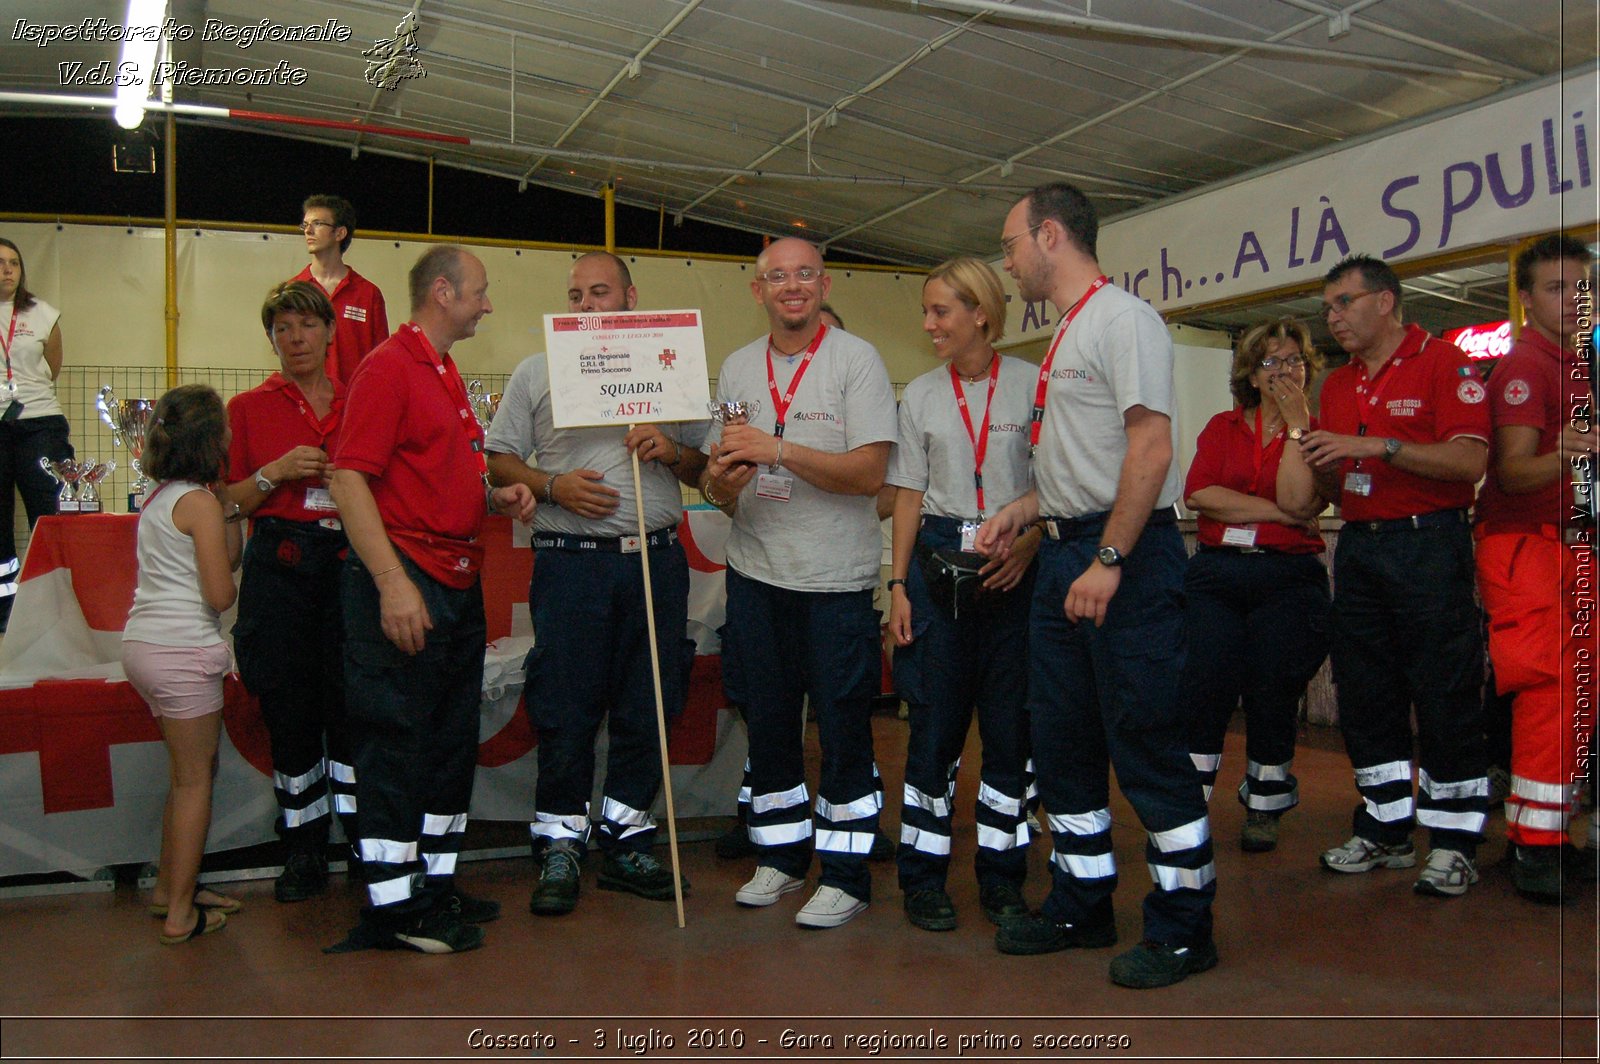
[293,195,389,389]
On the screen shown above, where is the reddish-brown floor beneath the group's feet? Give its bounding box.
[0,717,1597,1061]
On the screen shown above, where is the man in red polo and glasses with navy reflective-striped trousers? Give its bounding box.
[1302,256,1490,896]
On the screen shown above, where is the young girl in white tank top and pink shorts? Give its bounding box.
[122,384,240,946]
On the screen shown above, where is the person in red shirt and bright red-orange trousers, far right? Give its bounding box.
[1475,234,1595,902]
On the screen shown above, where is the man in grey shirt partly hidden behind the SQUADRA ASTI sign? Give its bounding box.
[485,251,706,915]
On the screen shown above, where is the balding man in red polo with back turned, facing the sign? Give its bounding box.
[333,245,534,954]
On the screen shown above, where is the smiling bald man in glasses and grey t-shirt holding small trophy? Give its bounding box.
[701,237,896,928]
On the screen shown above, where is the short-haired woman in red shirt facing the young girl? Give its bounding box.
[227,282,357,902]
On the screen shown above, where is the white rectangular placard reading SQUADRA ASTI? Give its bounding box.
[544,310,710,429]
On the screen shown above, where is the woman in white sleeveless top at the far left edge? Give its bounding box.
[0,237,72,634]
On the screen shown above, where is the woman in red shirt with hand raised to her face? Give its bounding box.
[1179,318,1328,853]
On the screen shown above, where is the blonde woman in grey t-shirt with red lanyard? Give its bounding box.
[886,258,1038,931]
